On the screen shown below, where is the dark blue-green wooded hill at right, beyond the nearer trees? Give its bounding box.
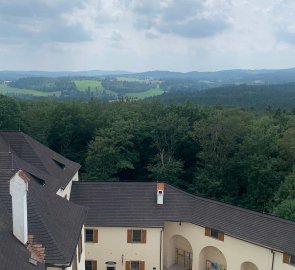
[153,83,295,110]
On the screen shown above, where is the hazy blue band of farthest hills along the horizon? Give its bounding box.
[0,68,295,85]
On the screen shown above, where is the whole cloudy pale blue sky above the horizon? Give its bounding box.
[0,0,295,72]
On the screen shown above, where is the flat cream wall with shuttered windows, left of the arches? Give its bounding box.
[85,227,161,270]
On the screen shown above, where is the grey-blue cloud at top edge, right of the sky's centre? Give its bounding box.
[129,0,231,38]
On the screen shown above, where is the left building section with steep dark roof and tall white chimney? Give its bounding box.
[0,132,86,270]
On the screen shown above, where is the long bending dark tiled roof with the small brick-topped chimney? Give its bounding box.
[71,182,295,254]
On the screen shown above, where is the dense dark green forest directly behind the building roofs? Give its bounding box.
[0,96,295,220]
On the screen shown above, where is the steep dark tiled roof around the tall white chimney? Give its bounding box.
[0,132,86,270]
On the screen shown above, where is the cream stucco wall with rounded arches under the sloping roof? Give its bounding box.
[163,222,295,270]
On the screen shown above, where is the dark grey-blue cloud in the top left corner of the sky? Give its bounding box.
[0,0,92,43]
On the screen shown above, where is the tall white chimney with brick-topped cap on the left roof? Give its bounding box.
[10,170,30,244]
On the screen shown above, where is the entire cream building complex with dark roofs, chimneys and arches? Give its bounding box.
[0,132,295,270]
